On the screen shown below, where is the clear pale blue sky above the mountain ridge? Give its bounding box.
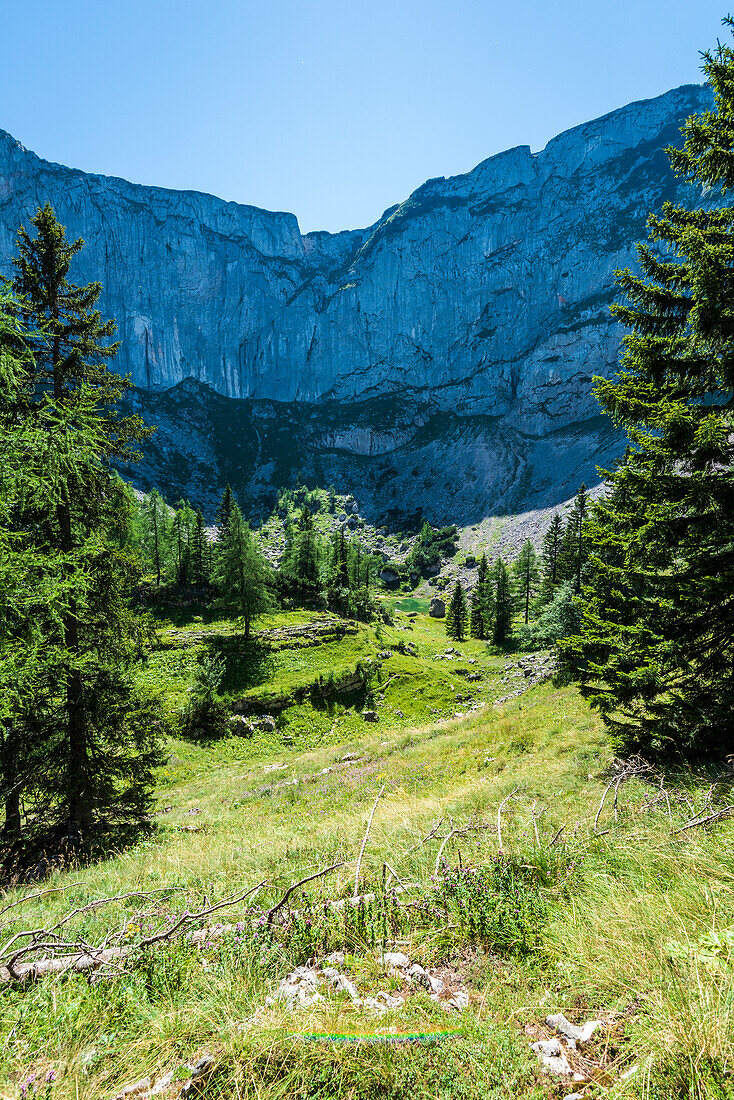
[0,0,726,231]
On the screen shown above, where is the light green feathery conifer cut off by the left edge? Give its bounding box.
[0,285,68,840]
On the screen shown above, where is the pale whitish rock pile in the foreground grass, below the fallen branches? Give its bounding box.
[265,952,469,1012]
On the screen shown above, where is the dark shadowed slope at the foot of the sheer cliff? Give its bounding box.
[117,378,625,529]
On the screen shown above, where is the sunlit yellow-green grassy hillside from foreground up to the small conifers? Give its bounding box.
[0,602,734,1100]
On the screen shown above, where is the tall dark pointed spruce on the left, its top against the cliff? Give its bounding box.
[2,212,158,845]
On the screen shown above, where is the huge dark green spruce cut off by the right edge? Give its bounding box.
[563,27,734,755]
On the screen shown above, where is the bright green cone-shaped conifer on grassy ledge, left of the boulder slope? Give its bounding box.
[217,501,271,641]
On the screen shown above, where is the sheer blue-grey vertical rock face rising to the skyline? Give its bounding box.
[0,86,711,517]
